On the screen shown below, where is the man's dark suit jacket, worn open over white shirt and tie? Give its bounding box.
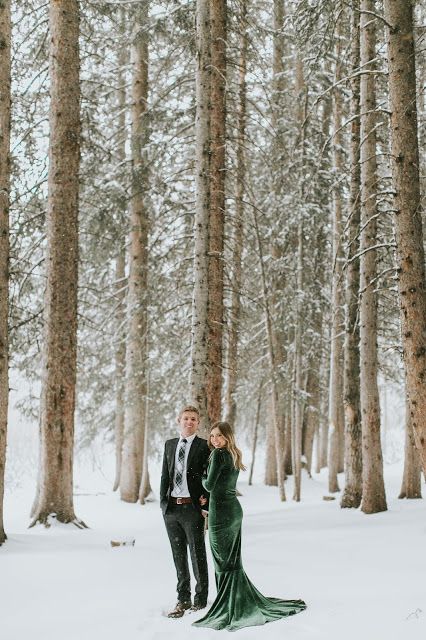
[160,436,210,514]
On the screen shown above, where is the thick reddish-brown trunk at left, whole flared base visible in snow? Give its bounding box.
[32,0,84,526]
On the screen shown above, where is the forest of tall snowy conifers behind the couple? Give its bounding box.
[0,0,426,548]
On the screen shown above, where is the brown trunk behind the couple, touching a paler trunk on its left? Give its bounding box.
[207,0,226,422]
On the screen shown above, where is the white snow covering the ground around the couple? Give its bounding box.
[0,444,426,640]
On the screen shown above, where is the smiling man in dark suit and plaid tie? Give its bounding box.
[160,406,210,618]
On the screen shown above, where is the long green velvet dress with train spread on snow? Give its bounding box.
[193,449,306,631]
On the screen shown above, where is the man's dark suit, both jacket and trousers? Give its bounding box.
[160,436,210,606]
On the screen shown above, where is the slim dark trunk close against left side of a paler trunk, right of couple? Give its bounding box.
[340,0,362,509]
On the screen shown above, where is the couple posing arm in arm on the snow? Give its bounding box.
[160,406,306,631]
